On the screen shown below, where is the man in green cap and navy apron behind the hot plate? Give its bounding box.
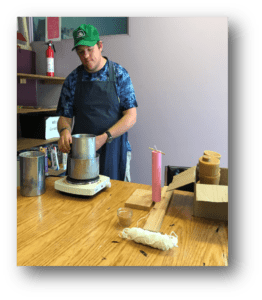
[56,24,138,181]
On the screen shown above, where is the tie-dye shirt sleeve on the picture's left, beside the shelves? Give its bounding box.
[56,74,76,118]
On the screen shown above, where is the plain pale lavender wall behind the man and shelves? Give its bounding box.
[32,17,228,186]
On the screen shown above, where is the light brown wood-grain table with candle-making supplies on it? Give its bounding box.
[16,177,228,266]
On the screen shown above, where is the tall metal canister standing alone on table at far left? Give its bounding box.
[19,151,46,197]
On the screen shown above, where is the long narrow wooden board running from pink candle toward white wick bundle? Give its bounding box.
[143,186,173,232]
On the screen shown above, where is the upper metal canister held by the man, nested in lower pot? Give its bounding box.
[72,134,96,159]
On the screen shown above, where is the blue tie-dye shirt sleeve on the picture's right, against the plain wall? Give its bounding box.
[116,65,138,111]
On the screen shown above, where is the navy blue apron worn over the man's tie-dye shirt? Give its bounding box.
[69,57,128,181]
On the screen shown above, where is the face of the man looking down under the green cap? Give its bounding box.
[76,43,103,73]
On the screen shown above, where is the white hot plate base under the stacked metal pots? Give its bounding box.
[55,175,111,196]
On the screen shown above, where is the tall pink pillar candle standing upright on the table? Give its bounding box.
[152,151,162,202]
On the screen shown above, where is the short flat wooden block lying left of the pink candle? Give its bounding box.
[125,189,154,211]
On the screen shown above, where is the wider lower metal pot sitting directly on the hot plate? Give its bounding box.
[68,154,100,180]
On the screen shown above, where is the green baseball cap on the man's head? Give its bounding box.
[72,24,100,51]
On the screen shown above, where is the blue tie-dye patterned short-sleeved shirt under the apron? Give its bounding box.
[56,56,138,151]
